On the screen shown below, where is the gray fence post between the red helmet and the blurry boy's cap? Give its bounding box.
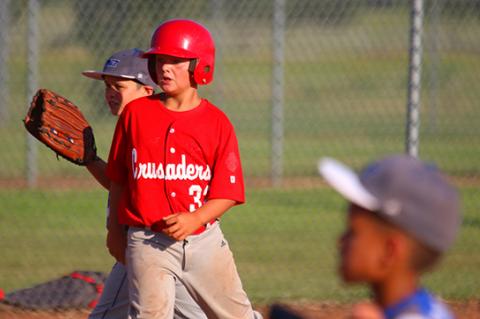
[271,0,285,186]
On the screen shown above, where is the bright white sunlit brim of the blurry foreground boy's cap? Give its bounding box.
[318,158,380,211]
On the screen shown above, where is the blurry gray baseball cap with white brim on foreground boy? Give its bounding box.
[318,155,461,252]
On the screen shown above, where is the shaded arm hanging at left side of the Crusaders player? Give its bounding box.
[107,182,127,264]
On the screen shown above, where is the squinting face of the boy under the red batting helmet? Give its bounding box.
[155,55,193,96]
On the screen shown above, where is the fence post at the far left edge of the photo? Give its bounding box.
[0,0,10,125]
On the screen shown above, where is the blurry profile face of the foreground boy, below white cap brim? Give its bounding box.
[339,204,386,283]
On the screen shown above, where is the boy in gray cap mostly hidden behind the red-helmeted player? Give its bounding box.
[82,49,206,319]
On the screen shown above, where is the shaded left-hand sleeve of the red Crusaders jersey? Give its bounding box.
[106,111,127,184]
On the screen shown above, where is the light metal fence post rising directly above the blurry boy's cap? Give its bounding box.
[406,0,423,157]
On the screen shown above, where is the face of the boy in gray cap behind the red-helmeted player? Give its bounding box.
[104,75,150,115]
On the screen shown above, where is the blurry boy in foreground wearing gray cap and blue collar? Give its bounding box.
[319,155,460,319]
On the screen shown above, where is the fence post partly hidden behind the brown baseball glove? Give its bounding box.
[26,0,39,188]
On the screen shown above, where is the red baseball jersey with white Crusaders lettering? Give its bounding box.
[107,95,245,230]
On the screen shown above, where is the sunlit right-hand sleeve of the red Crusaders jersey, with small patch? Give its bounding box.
[208,118,245,204]
